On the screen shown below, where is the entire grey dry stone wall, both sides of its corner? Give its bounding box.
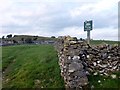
[55,36,120,88]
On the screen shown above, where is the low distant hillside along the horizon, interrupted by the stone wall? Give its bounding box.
[0,35,120,45]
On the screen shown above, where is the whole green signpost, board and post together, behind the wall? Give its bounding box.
[84,20,92,44]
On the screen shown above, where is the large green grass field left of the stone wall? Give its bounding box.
[2,45,64,88]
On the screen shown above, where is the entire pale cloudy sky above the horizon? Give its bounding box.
[0,0,119,41]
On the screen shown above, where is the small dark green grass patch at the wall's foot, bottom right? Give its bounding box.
[88,72,120,89]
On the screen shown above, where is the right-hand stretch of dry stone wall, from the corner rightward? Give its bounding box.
[84,45,120,76]
